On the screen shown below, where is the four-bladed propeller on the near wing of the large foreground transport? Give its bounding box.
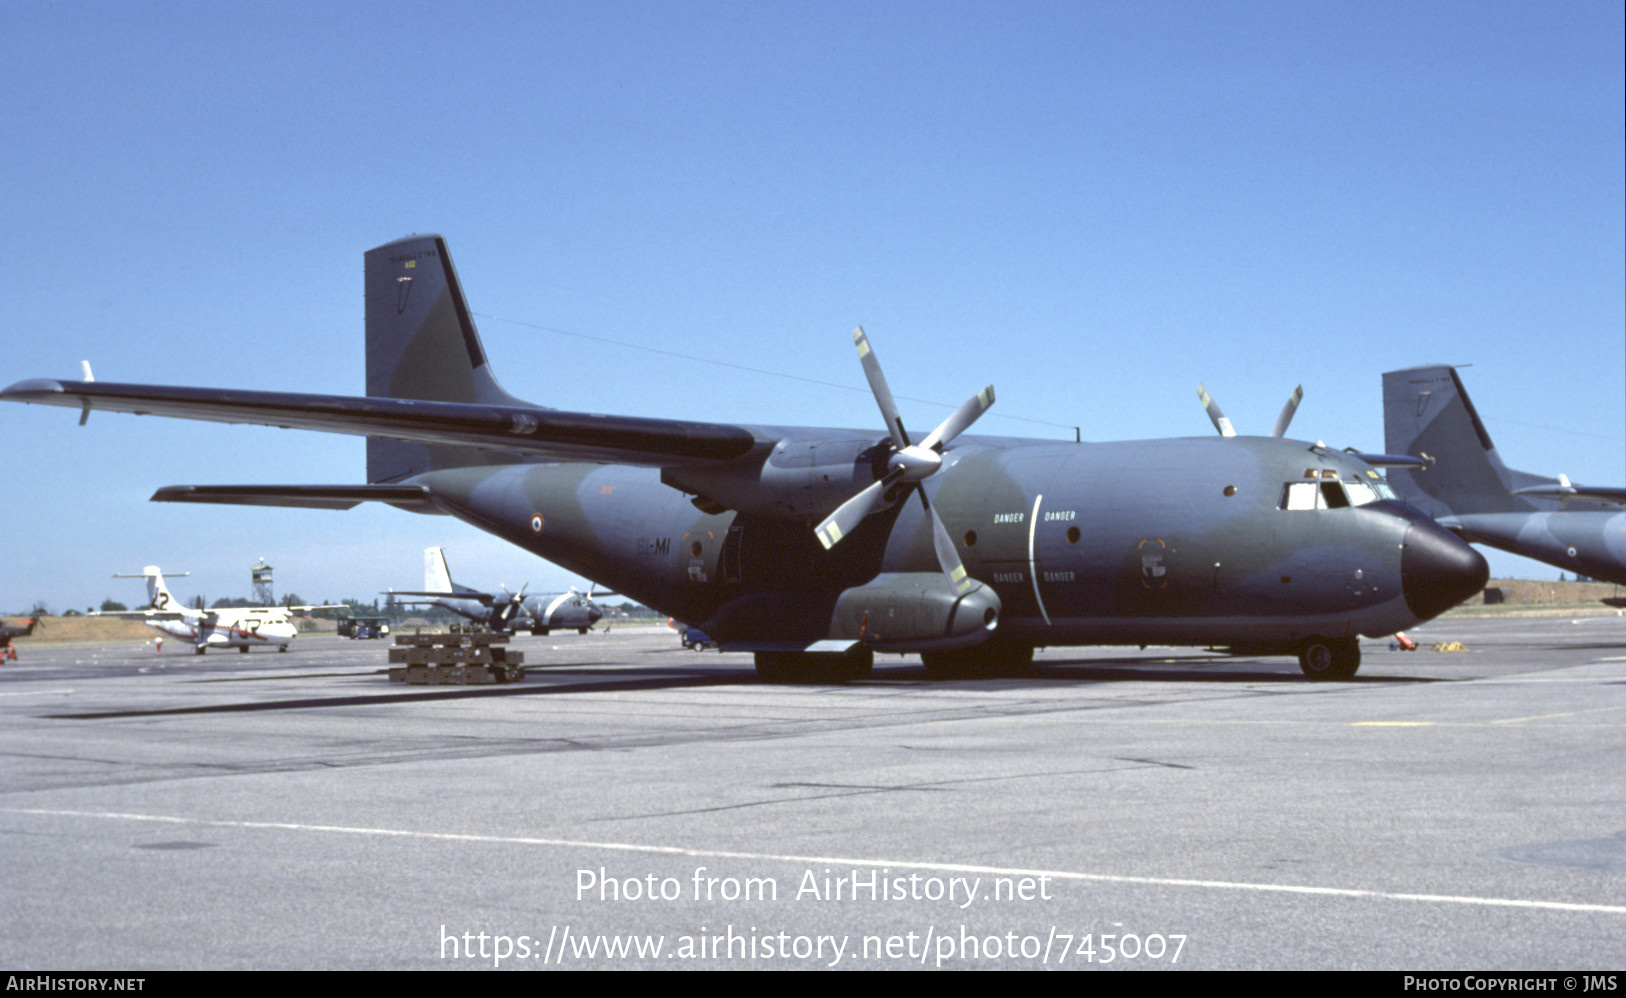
[815,327,993,595]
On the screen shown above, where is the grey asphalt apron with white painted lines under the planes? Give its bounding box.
[0,616,1626,972]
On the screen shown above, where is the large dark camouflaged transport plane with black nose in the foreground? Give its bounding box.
[0,236,1488,679]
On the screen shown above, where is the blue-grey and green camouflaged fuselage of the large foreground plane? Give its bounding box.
[411,429,1476,647]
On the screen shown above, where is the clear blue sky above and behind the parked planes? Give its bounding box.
[0,0,1626,613]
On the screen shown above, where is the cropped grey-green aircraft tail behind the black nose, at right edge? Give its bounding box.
[1384,364,1626,585]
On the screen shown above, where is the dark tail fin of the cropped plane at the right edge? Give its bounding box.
[1384,366,1553,515]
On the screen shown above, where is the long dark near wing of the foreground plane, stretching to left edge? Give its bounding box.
[0,379,758,468]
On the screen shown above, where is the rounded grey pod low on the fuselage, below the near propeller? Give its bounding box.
[829,572,1000,652]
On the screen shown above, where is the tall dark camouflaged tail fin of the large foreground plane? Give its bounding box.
[364,236,530,483]
